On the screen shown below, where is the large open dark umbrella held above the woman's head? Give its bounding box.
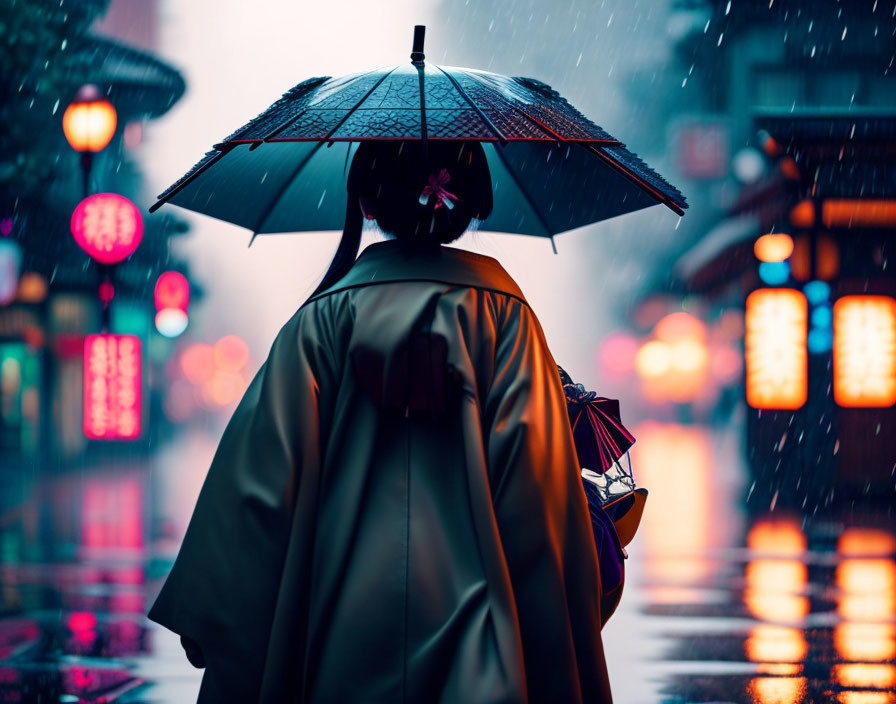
[150,25,687,239]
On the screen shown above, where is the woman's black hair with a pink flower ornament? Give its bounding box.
[312,140,492,295]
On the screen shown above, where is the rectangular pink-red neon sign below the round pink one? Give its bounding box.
[83,335,141,440]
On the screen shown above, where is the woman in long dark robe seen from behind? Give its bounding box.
[149,141,611,704]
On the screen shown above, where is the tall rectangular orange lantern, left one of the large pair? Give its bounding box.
[744,288,809,409]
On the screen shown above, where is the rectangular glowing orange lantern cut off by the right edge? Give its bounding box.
[834,296,896,408]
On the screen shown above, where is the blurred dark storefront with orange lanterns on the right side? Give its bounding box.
[638,0,896,514]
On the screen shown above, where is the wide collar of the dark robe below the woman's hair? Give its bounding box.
[306,240,528,305]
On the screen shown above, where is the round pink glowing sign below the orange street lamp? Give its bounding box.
[71,193,143,264]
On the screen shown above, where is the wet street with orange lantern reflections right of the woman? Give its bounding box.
[604,423,896,704]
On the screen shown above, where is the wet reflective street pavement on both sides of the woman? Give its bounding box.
[0,422,896,704]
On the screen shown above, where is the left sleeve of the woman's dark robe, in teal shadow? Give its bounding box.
[149,300,333,702]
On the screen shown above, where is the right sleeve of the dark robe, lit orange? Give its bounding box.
[484,301,610,701]
